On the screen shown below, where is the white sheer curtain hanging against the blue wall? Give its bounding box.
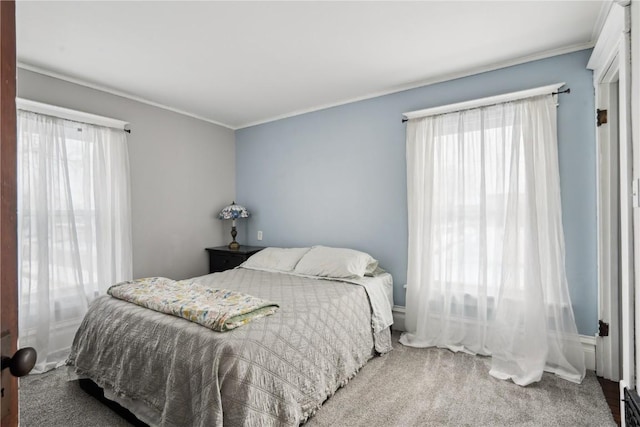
[400,95,585,385]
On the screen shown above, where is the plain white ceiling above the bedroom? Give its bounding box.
[16,0,610,129]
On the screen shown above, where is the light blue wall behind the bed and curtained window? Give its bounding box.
[236,50,597,335]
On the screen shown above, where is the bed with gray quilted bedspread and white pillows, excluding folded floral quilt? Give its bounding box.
[67,247,393,426]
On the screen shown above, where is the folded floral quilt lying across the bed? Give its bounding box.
[107,277,278,332]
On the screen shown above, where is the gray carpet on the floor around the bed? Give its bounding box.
[20,333,616,427]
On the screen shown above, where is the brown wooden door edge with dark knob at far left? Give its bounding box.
[0,0,18,427]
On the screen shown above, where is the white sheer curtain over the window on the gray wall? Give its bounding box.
[18,110,132,373]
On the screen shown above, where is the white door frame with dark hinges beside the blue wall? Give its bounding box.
[587,1,640,425]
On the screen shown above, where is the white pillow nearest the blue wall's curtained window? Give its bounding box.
[294,246,378,279]
